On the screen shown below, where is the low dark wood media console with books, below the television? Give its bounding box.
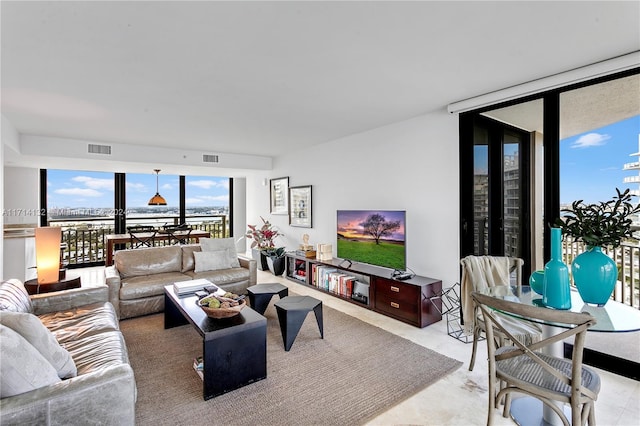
[285,253,442,328]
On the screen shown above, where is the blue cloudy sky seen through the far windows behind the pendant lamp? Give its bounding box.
[47,169,229,208]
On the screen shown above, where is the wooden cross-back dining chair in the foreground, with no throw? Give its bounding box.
[471,292,600,426]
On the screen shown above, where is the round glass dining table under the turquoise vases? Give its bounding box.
[479,286,640,426]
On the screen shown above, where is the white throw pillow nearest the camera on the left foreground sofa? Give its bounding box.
[0,325,60,398]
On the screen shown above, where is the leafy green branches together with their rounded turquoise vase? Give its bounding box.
[556,188,640,306]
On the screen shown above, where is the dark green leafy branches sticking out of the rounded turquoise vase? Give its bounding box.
[556,188,640,247]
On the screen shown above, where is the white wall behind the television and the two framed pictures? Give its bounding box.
[247,110,459,287]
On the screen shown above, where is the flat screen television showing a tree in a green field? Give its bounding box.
[336,210,406,271]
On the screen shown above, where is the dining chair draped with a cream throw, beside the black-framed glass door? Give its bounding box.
[460,256,542,371]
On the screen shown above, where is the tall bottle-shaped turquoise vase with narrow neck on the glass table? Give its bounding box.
[542,228,571,309]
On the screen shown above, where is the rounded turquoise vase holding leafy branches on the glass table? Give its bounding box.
[571,247,618,306]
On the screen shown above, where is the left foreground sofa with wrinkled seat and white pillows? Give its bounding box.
[0,279,136,426]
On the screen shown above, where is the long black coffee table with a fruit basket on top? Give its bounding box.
[164,285,267,400]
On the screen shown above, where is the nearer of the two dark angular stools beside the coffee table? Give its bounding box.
[275,296,324,352]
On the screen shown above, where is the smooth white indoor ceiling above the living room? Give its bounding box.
[0,1,640,163]
